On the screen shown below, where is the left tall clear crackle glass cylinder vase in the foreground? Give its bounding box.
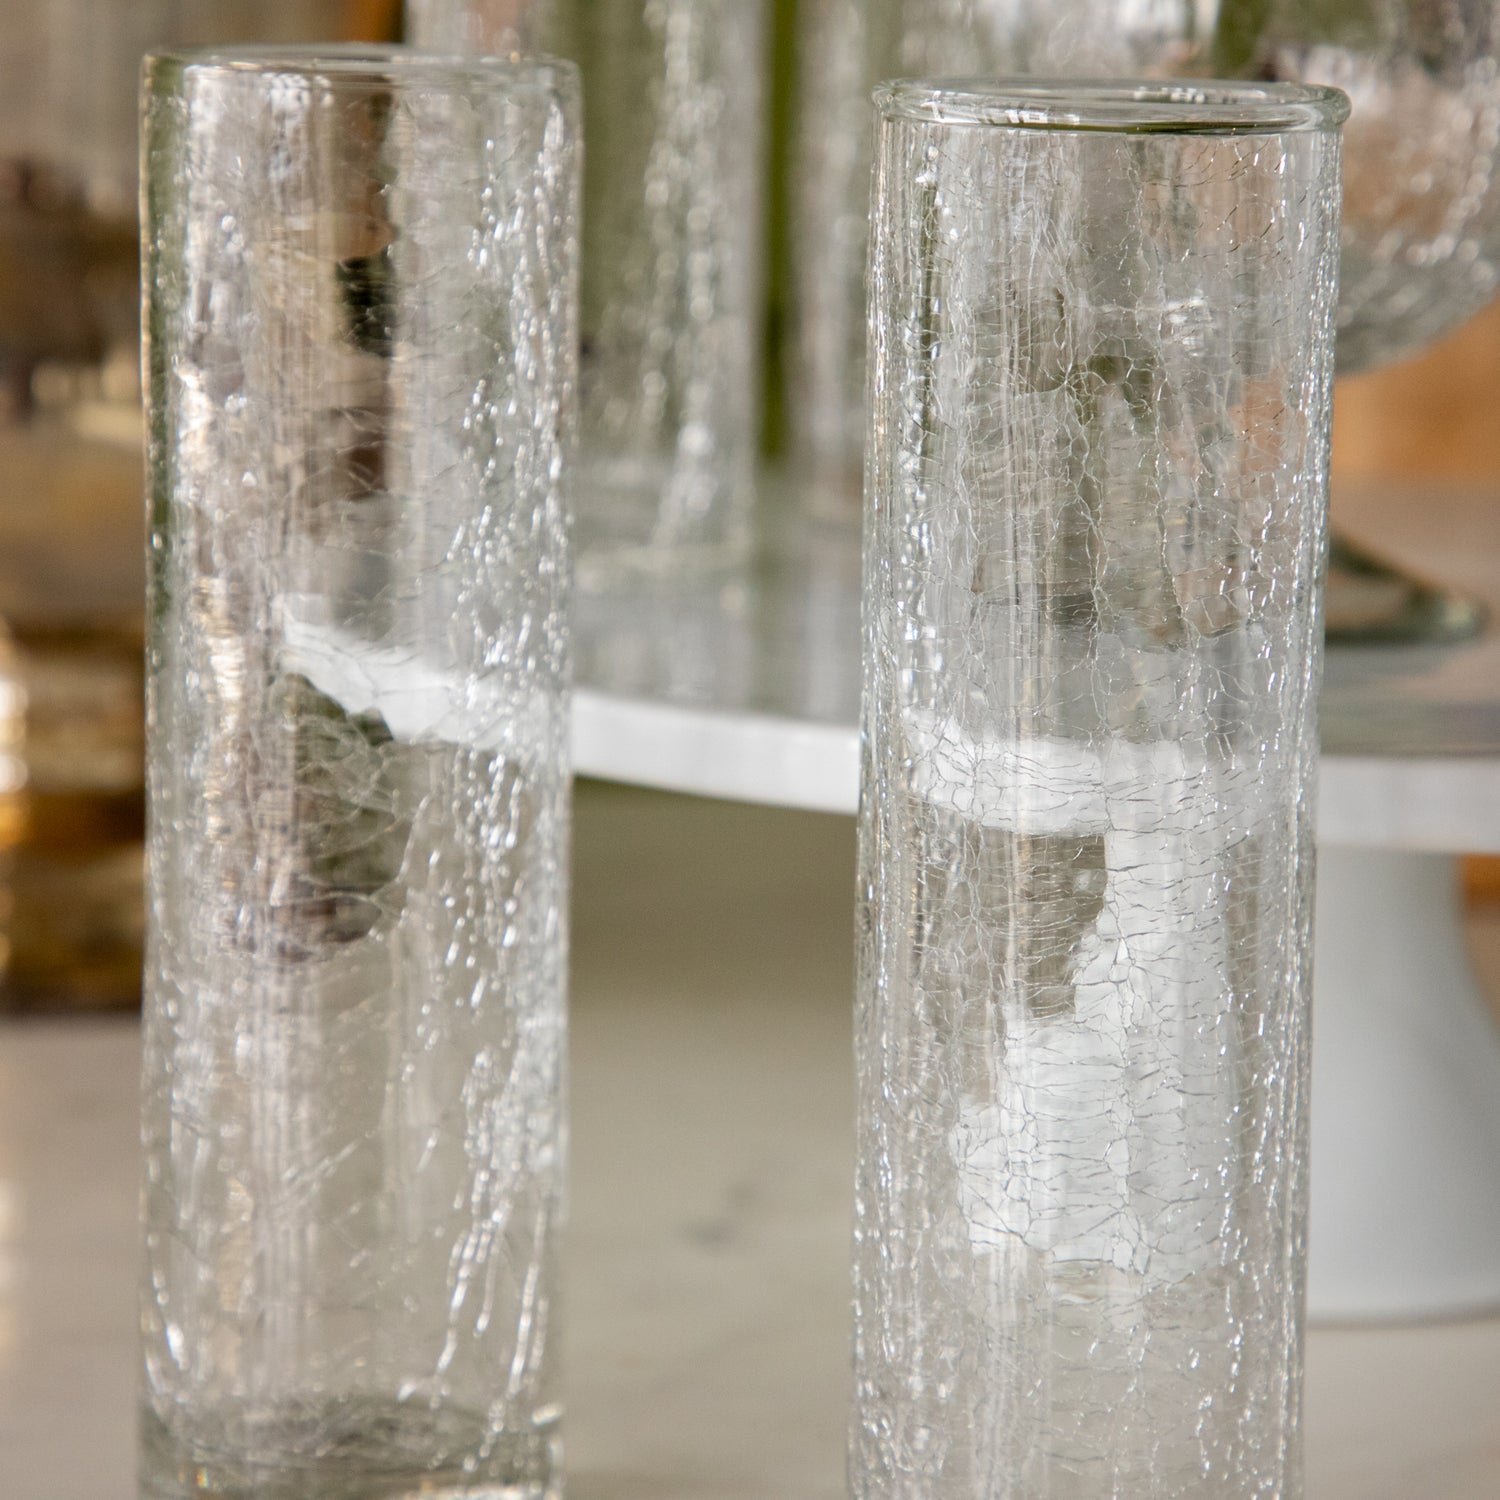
[141,50,578,1500]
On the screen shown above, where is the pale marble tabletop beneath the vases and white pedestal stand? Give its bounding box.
[0,786,1500,1500]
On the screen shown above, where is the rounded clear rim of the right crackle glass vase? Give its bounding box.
[873,77,1349,135]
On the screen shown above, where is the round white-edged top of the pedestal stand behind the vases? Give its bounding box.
[575,479,1500,852]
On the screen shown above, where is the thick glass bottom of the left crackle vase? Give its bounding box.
[138,1400,563,1500]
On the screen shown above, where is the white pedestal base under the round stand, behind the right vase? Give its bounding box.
[1308,846,1500,1320]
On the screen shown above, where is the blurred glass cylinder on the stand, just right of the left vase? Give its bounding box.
[408,0,767,584]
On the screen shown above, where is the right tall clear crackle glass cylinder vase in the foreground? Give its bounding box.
[851,84,1343,1500]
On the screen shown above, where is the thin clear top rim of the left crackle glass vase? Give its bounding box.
[141,42,579,93]
